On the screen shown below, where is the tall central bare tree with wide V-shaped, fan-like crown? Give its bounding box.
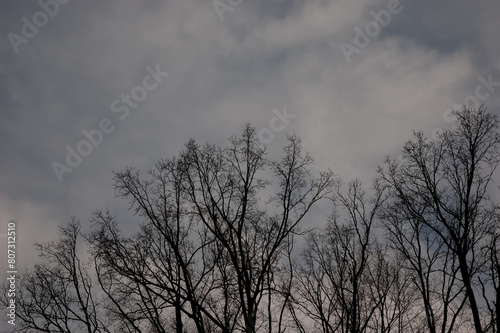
[177,126,332,333]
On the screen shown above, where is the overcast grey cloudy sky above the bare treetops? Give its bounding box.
[0,0,500,270]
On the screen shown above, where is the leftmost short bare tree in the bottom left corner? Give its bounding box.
[0,220,112,333]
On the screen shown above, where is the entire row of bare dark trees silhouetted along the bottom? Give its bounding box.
[0,107,500,333]
